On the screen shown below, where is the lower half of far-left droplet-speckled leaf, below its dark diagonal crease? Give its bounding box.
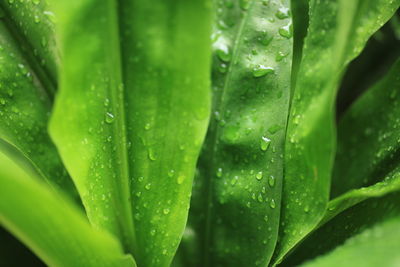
[0,5,76,197]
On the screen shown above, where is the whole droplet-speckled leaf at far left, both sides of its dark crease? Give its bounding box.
[0,1,76,196]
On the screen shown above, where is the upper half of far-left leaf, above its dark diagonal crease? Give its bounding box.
[0,0,59,97]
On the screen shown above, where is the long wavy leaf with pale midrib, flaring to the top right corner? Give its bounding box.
[274,0,400,263]
